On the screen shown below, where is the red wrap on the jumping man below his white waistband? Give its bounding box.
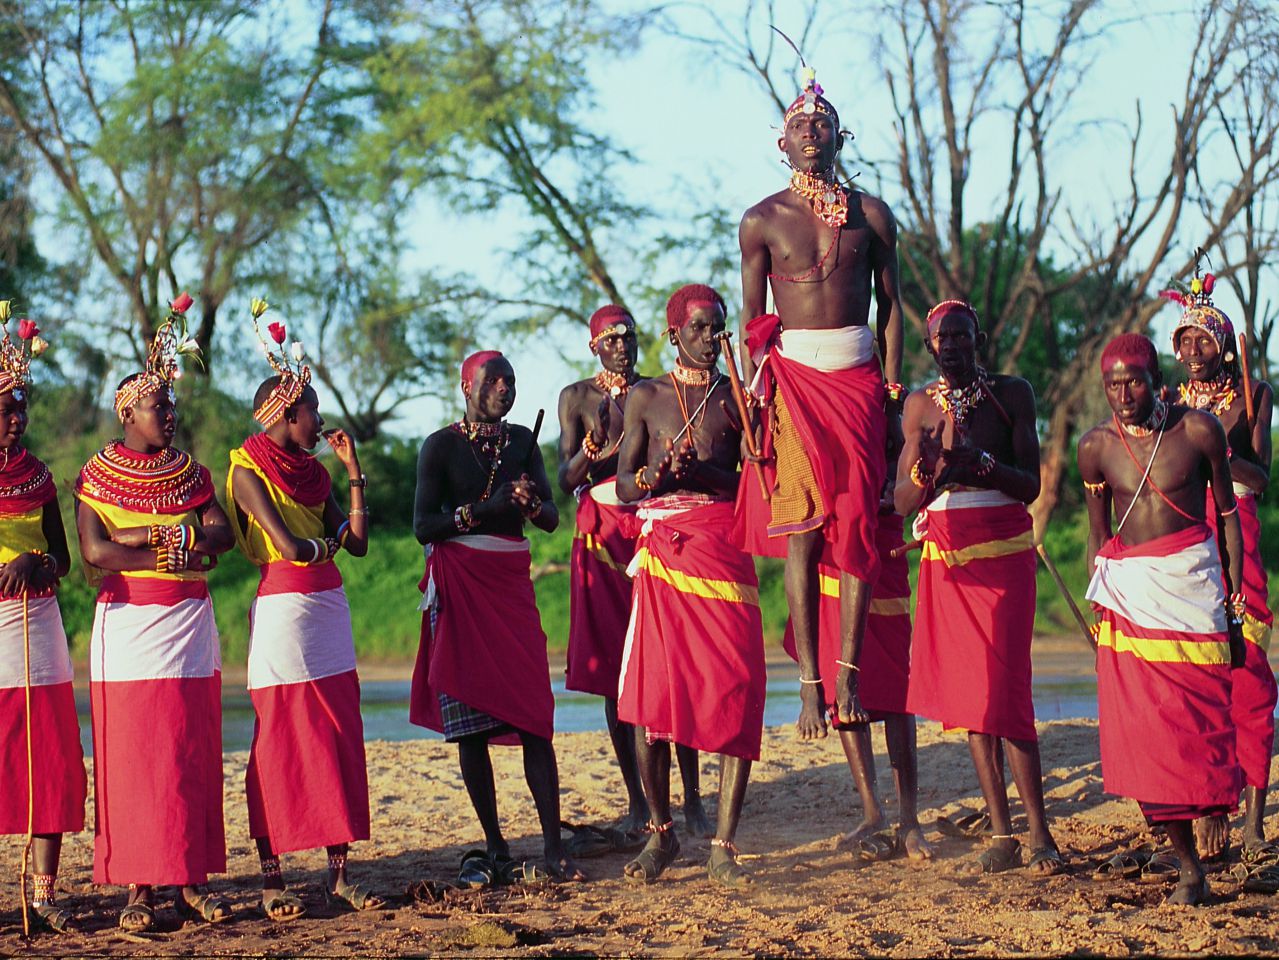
[733,350,886,583]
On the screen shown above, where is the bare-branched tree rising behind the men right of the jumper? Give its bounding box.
[680,0,1279,530]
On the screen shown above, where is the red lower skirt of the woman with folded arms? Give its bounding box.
[90,674,226,886]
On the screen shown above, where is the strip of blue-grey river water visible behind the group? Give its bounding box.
[75,665,1097,754]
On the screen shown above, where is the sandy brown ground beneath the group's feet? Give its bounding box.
[0,705,1279,956]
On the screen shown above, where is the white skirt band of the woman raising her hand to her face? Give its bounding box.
[248,587,356,690]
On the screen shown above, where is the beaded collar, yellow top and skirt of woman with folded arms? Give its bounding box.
[75,444,226,885]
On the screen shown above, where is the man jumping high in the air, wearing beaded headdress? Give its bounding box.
[734,70,904,739]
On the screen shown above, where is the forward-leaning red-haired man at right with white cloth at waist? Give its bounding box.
[1079,334,1247,905]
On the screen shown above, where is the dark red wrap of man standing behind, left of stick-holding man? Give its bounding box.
[564,491,636,699]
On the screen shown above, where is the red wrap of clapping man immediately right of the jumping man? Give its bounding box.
[907,504,1036,740]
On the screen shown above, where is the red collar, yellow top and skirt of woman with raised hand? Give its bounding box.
[226,442,368,854]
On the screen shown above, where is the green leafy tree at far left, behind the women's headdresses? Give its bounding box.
[0,0,345,370]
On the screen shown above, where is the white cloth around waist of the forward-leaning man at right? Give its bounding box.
[1083,537,1227,634]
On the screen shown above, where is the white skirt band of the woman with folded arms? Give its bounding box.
[88,597,223,683]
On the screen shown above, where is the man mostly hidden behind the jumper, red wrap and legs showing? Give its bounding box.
[783,472,932,860]
